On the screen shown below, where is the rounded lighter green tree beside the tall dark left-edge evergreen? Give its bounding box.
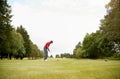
[0,30,25,59]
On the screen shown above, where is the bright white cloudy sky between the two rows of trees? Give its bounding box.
[8,0,110,55]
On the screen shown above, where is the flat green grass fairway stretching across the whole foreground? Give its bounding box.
[0,59,120,79]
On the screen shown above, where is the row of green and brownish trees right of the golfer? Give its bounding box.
[73,0,120,59]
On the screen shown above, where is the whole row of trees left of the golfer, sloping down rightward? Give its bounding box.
[0,0,43,59]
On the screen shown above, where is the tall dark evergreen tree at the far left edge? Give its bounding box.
[0,0,13,59]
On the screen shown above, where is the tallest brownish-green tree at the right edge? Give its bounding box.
[100,0,120,51]
